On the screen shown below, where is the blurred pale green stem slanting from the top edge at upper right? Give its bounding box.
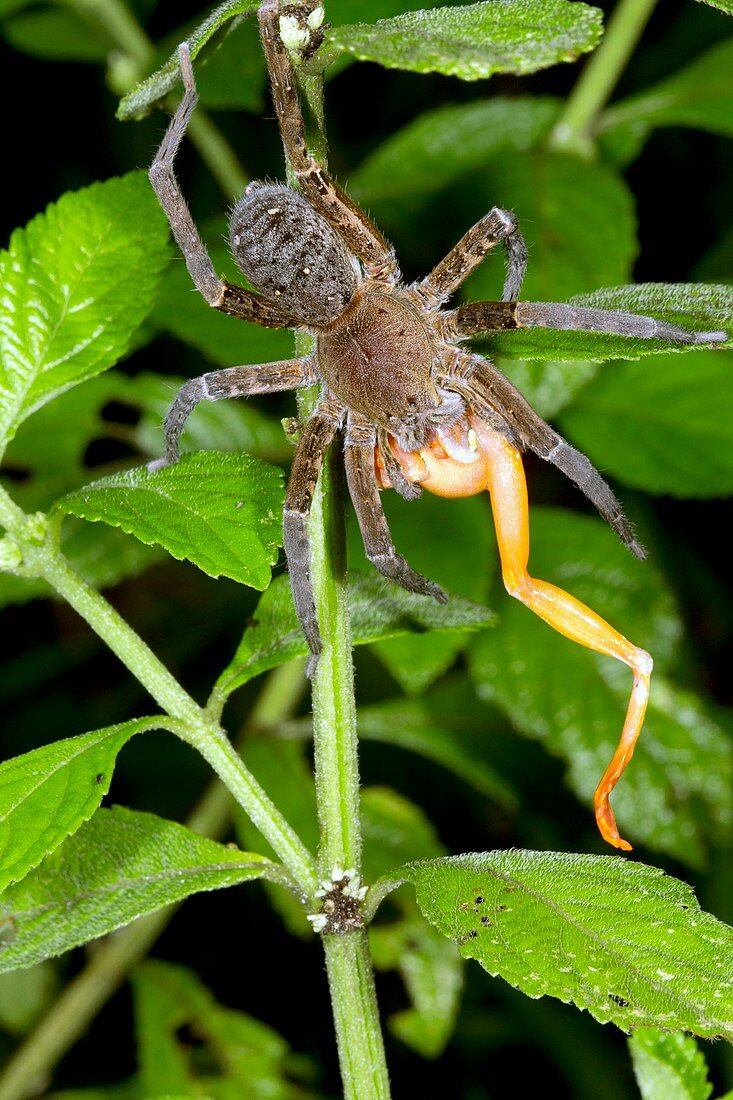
[548,0,657,156]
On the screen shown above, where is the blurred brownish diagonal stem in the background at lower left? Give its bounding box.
[0,660,304,1100]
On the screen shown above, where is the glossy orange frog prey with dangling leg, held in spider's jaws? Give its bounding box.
[393,415,653,851]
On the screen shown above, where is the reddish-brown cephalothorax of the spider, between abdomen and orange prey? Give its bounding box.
[318,293,438,444]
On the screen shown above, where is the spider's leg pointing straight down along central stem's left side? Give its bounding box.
[283,394,346,677]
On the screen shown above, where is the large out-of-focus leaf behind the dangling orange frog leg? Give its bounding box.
[471,508,733,866]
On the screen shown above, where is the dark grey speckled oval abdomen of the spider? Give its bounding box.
[229,182,359,328]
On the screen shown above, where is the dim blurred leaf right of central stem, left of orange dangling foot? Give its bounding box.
[359,679,517,810]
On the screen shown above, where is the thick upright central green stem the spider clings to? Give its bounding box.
[286,23,390,1100]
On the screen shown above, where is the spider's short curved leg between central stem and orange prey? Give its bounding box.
[343,413,448,604]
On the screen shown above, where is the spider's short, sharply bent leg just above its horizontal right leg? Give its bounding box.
[418,207,527,301]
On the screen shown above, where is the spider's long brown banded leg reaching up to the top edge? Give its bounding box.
[259,0,398,282]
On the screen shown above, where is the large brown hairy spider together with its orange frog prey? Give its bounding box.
[150,0,725,850]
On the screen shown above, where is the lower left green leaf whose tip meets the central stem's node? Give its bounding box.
[0,806,278,972]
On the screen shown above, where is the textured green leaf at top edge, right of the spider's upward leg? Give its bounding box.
[328,0,602,80]
